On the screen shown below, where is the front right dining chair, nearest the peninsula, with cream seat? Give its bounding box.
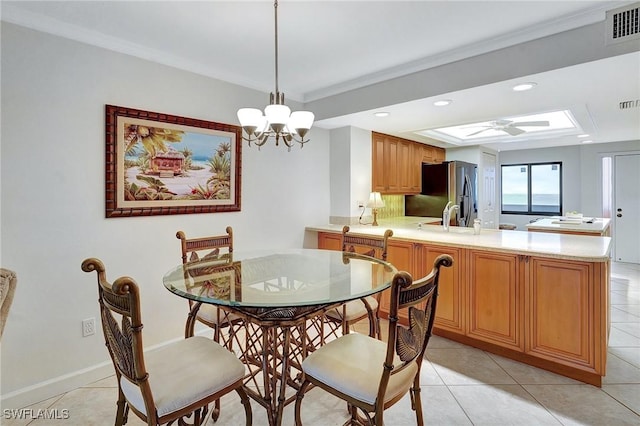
[295,255,453,425]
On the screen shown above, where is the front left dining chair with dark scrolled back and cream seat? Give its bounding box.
[82,258,252,426]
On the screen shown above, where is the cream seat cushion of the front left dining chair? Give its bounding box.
[120,336,245,416]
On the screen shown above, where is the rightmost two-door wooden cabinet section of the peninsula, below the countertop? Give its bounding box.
[466,250,609,386]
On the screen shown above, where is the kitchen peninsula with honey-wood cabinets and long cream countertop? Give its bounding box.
[306,218,611,386]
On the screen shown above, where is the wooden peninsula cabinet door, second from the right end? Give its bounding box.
[467,250,525,351]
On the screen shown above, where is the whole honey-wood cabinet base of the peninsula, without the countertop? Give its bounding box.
[318,232,610,386]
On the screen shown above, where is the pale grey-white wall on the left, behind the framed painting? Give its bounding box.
[0,22,329,408]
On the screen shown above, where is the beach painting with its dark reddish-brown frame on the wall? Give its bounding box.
[105,105,242,218]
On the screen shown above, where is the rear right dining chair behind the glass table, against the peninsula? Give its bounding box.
[325,226,393,338]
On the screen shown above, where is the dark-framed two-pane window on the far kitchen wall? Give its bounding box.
[502,162,562,216]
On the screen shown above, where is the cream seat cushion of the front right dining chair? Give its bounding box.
[302,333,418,404]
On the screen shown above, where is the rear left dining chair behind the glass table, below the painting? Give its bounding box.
[176,226,242,342]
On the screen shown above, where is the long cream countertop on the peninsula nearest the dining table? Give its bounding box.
[306,216,611,262]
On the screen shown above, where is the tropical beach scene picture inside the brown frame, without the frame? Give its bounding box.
[119,117,235,209]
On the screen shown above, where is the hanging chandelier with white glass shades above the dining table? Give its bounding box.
[238,0,314,151]
